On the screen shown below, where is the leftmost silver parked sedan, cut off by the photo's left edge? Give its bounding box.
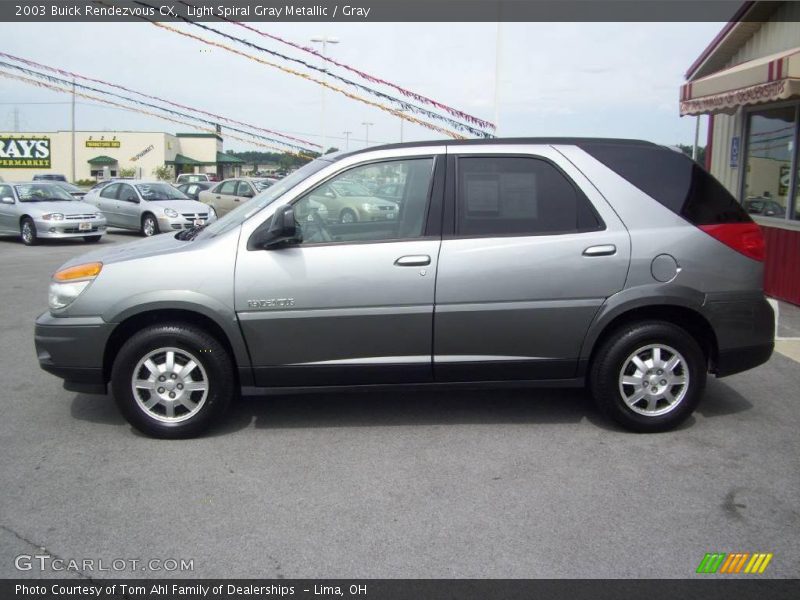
[0,182,106,246]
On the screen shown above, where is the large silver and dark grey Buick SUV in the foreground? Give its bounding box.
[36,139,774,437]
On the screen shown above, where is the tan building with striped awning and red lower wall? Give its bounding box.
[680,2,800,304]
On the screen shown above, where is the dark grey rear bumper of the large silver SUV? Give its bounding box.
[704,294,775,377]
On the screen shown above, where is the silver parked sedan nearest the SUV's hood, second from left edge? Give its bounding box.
[84,180,216,237]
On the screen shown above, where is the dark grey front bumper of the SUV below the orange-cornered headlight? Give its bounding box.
[34,312,114,394]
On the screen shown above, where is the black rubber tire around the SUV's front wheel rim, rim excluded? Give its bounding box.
[111,324,237,438]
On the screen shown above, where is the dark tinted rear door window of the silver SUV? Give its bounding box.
[456,156,603,236]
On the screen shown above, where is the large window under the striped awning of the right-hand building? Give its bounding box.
[742,105,800,219]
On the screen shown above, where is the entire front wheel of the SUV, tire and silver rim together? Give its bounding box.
[111,323,237,439]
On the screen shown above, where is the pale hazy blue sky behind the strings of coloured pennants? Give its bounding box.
[0,23,723,149]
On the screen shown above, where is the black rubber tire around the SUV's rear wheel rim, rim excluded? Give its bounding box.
[590,321,707,432]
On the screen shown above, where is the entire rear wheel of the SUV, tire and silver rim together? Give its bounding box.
[589,321,707,433]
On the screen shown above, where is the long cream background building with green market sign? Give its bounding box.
[0,131,243,181]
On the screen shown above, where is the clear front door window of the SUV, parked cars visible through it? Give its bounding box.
[294,158,433,245]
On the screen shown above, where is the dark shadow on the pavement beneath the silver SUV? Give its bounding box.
[71,378,753,437]
